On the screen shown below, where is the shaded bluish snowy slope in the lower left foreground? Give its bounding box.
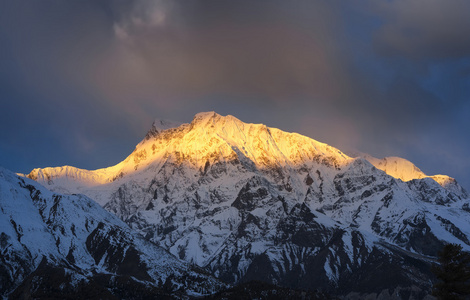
[0,168,225,299]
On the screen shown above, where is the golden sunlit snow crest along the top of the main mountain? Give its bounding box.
[27,112,455,188]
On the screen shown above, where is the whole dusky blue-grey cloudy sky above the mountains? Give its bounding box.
[0,0,470,190]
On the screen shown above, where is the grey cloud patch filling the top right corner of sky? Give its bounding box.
[373,0,470,59]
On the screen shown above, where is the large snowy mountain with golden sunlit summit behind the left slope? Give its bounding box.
[27,112,470,298]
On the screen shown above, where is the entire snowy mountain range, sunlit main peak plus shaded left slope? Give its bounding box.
[0,112,470,299]
